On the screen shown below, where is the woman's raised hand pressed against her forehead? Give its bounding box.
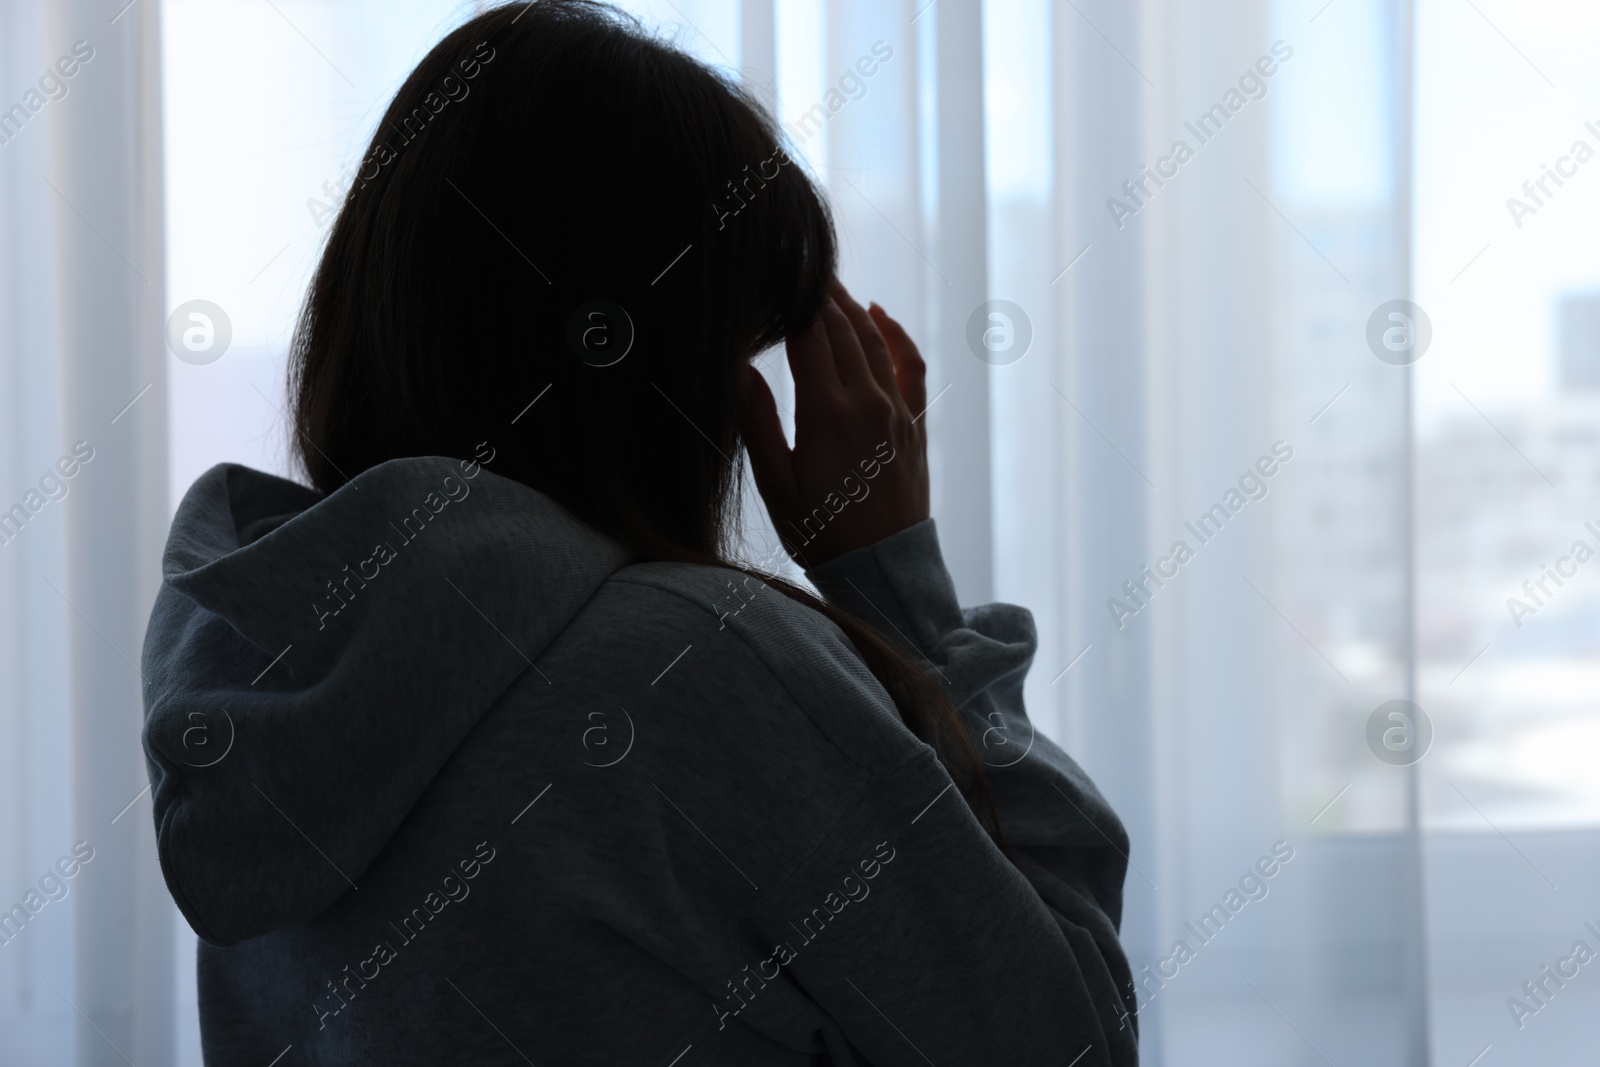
[744,282,928,568]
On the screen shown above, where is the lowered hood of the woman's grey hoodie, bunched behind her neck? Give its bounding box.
[144,450,630,945]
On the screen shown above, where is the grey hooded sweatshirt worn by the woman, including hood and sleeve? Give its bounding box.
[144,458,1136,1067]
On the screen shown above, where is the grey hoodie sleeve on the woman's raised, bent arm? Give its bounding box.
[808,518,1136,1062]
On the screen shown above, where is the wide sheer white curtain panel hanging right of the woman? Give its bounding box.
[778,0,1427,1064]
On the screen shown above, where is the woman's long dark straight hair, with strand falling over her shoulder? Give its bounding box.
[290,0,1000,840]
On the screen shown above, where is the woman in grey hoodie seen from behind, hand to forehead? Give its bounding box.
[144,0,1136,1067]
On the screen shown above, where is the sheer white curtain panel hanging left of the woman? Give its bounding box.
[0,0,174,1064]
